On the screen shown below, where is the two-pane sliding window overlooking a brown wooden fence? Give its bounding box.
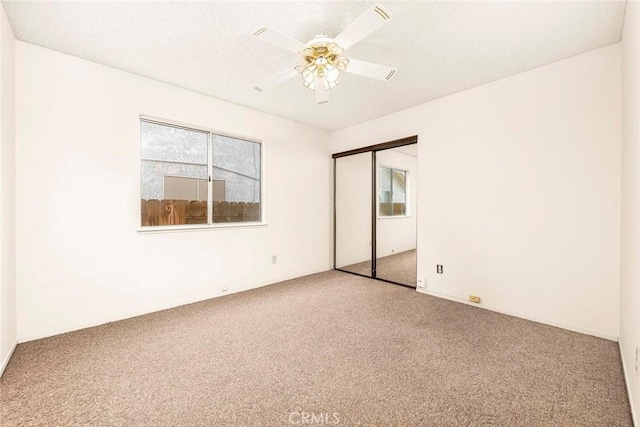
[140,119,262,227]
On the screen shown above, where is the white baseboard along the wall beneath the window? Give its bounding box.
[17,268,329,344]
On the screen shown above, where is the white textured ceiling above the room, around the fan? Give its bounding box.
[3,1,625,130]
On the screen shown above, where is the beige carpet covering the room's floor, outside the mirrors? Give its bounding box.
[0,271,631,427]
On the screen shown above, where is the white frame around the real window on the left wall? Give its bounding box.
[136,114,268,233]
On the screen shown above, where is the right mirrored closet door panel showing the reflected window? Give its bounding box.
[376,144,418,287]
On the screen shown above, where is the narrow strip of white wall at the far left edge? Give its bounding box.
[0,6,16,375]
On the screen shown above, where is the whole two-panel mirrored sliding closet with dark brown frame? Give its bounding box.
[333,136,417,288]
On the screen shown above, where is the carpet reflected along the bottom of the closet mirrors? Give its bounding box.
[340,249,417,288]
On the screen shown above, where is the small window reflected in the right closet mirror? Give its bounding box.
[378,166,407,216]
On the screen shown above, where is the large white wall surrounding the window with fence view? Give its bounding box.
[16,42,331,341]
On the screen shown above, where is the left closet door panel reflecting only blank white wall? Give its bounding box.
[335,152,373,277]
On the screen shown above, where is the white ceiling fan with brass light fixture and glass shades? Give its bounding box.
[253,4,396,104]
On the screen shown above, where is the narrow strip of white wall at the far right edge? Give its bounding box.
[620,1,640,425]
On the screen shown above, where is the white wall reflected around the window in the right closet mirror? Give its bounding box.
[376,150,418,258]
